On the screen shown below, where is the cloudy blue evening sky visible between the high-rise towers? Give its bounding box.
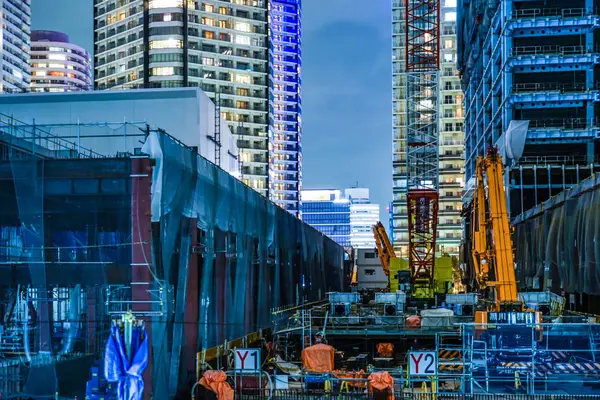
[31,0,392,222]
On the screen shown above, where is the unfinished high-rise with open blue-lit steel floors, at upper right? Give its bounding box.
[457,0,600,218]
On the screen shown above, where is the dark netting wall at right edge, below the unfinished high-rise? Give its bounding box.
[513,176,600,295]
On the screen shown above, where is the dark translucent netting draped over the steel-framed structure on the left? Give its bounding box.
[0,114,344,399]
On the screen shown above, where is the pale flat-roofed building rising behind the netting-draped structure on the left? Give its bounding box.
[0,88,239,177]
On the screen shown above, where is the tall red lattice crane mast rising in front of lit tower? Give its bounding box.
[405,0,440,298]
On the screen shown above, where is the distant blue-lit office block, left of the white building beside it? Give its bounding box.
[302,189,350,247]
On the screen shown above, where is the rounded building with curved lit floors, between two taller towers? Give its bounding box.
[31,31,92,92]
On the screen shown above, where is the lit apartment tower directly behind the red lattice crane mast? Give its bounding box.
[390,0,464,257]
